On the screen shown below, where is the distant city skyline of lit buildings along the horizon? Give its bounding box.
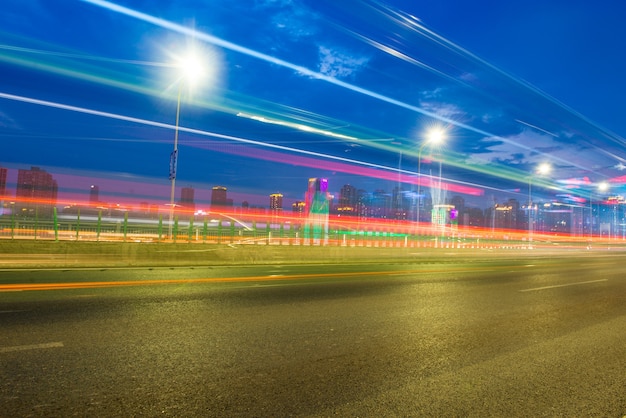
[0,167,626,236]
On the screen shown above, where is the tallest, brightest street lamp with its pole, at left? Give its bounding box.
[168,53,204,238]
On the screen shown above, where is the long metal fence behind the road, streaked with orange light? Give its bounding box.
[0,207,615,249]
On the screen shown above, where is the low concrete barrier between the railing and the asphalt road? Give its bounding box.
[0,239,616,269]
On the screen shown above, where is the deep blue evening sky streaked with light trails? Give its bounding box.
[0,0,626,207]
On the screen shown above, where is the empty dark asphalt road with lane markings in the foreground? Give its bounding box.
[0,252,626,417]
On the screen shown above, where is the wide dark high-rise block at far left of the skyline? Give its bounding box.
[15,167,58,218]
